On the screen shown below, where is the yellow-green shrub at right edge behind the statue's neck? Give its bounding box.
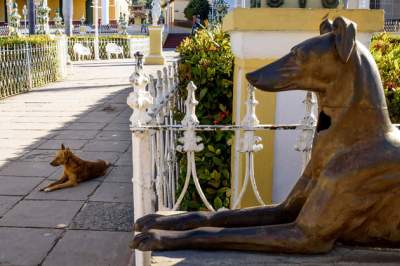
[371,33,400,123]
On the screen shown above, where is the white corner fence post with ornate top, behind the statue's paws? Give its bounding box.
[127,60,155,266]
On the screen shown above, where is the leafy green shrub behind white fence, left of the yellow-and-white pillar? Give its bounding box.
[174,27,234,210]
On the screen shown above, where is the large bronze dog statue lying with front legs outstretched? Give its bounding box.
[133,17,400,253]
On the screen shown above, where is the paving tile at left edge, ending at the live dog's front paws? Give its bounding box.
[0,176,44,196]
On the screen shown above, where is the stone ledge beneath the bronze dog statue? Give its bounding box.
[151,246,400,266]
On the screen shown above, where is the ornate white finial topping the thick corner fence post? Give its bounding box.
[127,69,153,127]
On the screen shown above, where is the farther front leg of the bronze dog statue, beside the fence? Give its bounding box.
[135,161,314,232]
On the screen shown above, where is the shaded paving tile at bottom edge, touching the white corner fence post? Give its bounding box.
[43,230,132,266]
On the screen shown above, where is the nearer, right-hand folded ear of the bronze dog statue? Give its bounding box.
[333,17,357,63]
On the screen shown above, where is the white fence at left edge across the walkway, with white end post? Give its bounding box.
[0,39,66,98]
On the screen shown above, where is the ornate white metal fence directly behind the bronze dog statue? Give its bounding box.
[127,60,316,266]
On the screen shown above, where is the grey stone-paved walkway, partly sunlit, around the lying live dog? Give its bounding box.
[0,54,178,266]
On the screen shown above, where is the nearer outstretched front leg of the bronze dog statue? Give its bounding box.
[133,223,334,254]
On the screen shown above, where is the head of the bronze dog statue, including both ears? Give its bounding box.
[246,17,356,92]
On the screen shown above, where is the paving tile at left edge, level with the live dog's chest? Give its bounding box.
[0,161,55,177]
